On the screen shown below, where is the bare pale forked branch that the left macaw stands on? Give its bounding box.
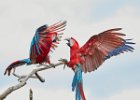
[0,62,65,100]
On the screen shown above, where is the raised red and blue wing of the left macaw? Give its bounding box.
[30,21,66,62]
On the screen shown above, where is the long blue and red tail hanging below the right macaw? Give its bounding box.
[72,64,86,100]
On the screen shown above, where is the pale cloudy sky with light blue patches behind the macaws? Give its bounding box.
[0,0,140,100]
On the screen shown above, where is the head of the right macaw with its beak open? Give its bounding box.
[65,37,79,48]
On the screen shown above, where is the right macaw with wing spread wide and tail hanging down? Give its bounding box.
[63,28,135,100]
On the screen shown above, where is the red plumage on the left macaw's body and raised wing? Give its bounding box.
[30,21,66,63]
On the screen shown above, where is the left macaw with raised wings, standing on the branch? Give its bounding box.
[4,21,66,75]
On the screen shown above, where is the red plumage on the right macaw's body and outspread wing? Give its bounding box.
[68,28,133,73]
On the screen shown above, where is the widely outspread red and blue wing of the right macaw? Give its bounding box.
[80,28,135,72]
